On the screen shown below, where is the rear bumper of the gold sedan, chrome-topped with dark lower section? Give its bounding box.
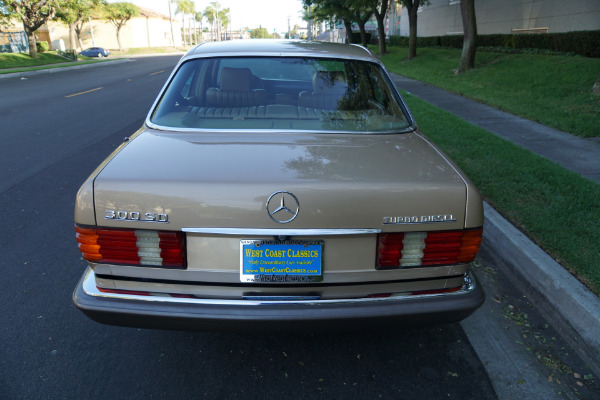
[73,268,485,331]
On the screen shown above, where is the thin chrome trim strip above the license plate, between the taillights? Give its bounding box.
[181,228,381,236]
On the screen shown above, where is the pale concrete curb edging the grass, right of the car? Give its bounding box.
[480,203,600,376]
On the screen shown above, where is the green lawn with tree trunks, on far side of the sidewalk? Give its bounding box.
[381,47,600,137]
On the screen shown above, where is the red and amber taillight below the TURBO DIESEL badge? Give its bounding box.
[377,228,483,269]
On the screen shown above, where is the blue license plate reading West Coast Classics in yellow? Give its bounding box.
[240,240,323,283]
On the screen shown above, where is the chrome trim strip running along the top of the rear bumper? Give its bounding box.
[82,267,476,307]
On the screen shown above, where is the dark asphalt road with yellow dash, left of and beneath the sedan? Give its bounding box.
[0,56,596,399]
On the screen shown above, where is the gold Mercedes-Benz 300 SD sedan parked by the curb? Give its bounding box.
[73,40,484,330]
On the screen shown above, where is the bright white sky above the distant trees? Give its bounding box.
[109,0,306,33]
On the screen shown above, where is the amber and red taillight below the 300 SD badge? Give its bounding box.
[75,226,185,268]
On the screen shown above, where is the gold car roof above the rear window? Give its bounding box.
[182,39,379,63]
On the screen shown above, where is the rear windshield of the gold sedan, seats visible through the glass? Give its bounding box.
[151,57,410,132]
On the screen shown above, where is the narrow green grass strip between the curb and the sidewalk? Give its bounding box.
[404,93,600,295]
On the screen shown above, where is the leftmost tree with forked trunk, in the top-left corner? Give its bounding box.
[3,0,56,58]
